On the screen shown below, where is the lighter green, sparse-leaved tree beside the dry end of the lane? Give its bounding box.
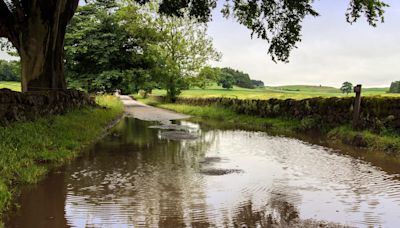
[156,12,220,102]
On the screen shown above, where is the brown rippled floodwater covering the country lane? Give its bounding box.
[6,118,400,228]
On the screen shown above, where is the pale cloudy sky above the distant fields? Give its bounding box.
[0,0,400,87]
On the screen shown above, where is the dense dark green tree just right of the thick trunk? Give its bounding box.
[65,1,159,93]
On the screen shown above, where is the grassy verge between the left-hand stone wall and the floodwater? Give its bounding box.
[0,96,123,223]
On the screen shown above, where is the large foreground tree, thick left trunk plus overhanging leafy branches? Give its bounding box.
[0,0,387,91]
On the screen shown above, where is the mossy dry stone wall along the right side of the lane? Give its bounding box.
[158,97,400,132]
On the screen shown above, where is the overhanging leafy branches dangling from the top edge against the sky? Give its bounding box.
[136,0,389,62]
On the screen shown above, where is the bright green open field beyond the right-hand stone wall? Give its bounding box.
[148,85,400,100]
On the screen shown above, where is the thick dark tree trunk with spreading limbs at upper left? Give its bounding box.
[0,0,79,92]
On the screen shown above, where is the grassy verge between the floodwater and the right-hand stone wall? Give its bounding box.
[139,98,400,155]
